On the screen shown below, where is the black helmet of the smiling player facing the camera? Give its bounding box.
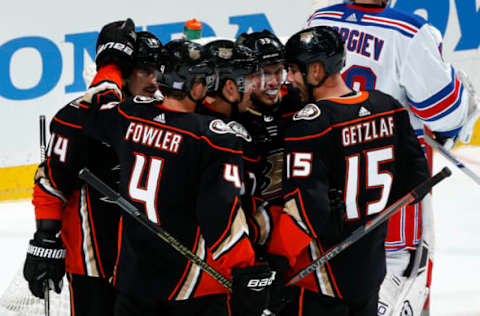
[235,30,285,66]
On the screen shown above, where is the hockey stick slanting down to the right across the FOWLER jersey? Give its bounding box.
[78,168,232,291]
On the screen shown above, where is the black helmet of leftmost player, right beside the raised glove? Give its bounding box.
[133,31,163,66]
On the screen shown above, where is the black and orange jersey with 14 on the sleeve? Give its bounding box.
[32,99,120,278]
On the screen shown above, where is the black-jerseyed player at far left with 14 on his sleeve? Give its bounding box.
[24,26,161,316]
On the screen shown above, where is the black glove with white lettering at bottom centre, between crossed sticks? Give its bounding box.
[230,264,275,316]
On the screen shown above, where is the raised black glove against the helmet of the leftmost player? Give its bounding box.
[95,19,137,72]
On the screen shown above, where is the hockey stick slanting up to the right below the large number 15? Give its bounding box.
[285,167,452,286]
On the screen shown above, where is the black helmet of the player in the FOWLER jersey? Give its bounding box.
[157,39,214,94]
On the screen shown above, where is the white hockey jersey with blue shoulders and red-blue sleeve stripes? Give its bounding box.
[307,3,468,143]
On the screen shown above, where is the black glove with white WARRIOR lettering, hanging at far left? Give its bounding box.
[23,231,65,298]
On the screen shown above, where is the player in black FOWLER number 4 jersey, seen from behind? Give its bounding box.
[81,20,271,316]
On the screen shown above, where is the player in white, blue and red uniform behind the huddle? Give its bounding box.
[307,0,474,315]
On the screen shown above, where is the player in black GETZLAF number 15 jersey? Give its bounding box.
[271,26,428,316]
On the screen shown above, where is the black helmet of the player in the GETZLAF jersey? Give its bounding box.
[285,26,345,76]
